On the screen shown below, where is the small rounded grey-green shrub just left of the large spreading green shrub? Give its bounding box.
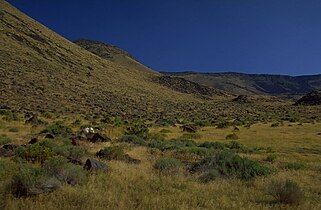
[154,158,183,173]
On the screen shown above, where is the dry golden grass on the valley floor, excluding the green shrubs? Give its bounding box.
[0,117,321,209]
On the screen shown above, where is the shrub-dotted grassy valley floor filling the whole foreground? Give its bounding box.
[0,109,321,209]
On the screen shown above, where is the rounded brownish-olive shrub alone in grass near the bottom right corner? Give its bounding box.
[268,180,304,205]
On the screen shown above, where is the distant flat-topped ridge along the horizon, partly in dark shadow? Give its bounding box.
[164,72,321,95]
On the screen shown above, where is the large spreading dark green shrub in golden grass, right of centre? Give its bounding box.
[192,150,271,180]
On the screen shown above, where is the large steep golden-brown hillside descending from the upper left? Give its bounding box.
[0,0,212,114]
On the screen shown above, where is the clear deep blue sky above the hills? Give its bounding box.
[8,0,321,75]
